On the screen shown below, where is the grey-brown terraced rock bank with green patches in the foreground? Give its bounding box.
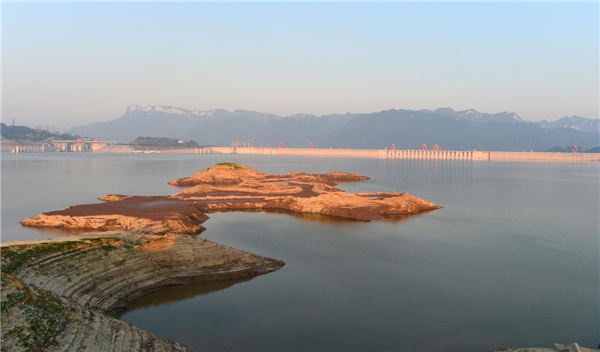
[1,232,284,352]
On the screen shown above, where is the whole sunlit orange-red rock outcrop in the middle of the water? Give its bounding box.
[21,163,440,234]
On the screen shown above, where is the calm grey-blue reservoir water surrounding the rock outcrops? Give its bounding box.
[2,154,600,351]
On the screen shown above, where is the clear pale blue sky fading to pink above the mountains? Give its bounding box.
[2,2,599,129]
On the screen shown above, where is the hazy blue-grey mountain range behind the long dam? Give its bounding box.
[71,105,600,151]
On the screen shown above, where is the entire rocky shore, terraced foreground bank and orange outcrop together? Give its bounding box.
[1,163,440,352]
